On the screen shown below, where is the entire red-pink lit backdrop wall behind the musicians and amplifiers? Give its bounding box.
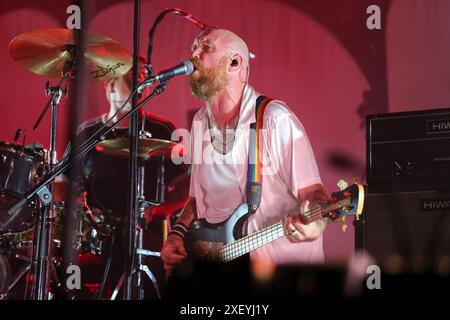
[0,0,450,261]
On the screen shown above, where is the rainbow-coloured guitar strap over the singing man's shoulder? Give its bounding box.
[247,96,272,213]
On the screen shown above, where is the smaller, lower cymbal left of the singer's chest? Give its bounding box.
[96,138,178,158]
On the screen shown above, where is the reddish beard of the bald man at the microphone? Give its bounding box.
[189,57,229,100]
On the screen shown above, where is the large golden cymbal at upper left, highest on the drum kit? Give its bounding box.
[9,29,133,80]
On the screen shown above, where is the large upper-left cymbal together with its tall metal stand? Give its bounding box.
[5,29,137,300]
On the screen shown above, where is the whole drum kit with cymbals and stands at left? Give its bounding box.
[0,29,189,300]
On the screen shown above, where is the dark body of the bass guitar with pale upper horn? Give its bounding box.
[186,203,248,260]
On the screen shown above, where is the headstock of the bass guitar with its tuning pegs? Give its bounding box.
[322,184,365,221]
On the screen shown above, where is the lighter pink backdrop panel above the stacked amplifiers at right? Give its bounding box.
[386,0,450,112]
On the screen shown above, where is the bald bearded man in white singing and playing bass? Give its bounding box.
[161,29,327,274]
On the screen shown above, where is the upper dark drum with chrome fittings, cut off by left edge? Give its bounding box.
[0,142,45,233]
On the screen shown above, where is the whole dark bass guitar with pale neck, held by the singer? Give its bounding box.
[186,184,365,262]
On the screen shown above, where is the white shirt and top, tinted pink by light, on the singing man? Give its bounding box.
[189,85,324,264]
